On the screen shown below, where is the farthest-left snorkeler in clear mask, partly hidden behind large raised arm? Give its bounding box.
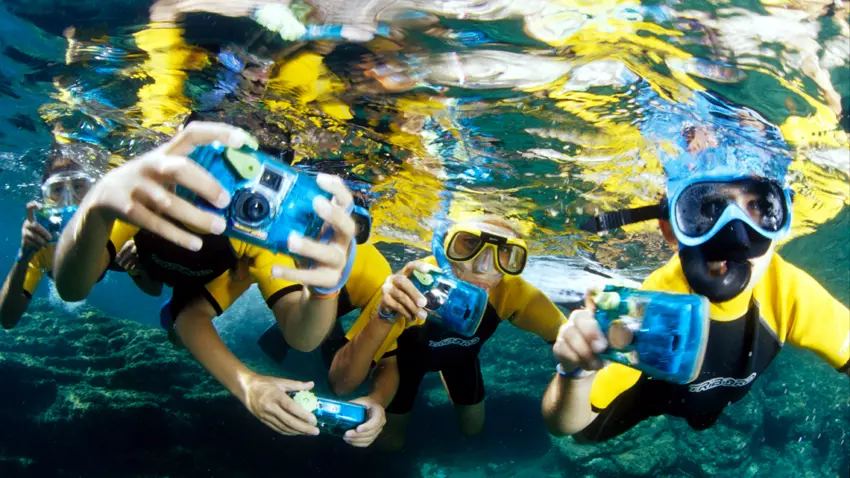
[0,145,159,329]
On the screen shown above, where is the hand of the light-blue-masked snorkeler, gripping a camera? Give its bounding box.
[552,291,608,373]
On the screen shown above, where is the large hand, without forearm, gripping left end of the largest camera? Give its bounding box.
[78,121,256,251]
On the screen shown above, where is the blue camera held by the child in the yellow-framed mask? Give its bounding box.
[410,270,487,337]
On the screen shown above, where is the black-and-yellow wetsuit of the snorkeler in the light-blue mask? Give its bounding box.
[577,254,850,441]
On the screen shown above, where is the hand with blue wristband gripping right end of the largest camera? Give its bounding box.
[272,174,356,288]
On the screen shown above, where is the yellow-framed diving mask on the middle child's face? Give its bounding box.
[446,225,528,275]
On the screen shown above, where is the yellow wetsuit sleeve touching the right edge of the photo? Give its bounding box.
[765,257,850,373]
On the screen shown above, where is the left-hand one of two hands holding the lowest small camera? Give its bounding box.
[242,375,319,436]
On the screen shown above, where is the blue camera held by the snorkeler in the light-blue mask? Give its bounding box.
[594,285,710,385]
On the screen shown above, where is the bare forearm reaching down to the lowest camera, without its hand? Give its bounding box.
[175,304,254,403]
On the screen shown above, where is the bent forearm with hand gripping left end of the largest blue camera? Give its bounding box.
[54,122,256,302]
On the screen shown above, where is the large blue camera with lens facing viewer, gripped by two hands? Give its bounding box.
[178,142,371,254]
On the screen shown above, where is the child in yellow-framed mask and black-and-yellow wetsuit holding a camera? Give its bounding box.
[329,217,565,449]
